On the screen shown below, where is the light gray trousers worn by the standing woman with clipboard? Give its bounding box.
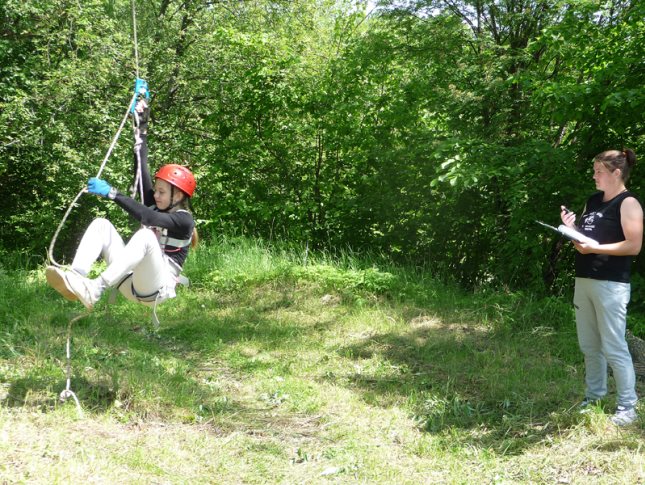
[573,278,638,407]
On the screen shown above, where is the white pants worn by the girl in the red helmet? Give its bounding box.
[72,218,179,304]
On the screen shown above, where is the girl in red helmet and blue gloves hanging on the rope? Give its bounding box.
[46,99,197,310]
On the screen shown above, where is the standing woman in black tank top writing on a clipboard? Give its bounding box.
[560,150,643,426]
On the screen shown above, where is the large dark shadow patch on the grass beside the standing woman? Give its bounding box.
[332,319,645,454]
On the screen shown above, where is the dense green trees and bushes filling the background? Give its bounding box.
[0,0,645,295]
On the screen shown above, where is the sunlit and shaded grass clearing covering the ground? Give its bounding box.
[0,239,645,484]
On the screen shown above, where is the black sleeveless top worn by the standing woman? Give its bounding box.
[576,191,636,283]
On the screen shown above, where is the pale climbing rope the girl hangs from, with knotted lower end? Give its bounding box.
[47,0,148,417]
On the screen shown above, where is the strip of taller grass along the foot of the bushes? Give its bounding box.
[186,236,573,332]
